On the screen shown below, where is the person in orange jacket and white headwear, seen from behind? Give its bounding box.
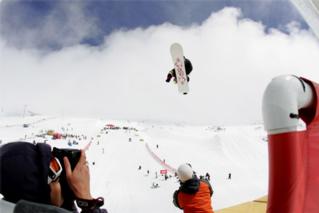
[173,164,213,213]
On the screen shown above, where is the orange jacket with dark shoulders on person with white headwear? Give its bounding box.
[174,178,214,213]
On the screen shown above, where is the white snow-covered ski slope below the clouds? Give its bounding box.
[0,116,268,213]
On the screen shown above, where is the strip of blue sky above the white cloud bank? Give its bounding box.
[0,0,307,50]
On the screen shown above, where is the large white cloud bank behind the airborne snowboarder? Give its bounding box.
[0,8,319,125]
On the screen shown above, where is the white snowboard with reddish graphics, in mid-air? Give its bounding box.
[170,43,189,95]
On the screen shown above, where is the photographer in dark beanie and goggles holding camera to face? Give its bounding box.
[0,142,107,213]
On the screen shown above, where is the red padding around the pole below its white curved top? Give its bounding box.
[267,79,319,213]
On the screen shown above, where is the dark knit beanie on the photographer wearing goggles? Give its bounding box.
[0,142,51,204]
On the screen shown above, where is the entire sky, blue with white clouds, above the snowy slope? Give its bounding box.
[0,0,319,125]
